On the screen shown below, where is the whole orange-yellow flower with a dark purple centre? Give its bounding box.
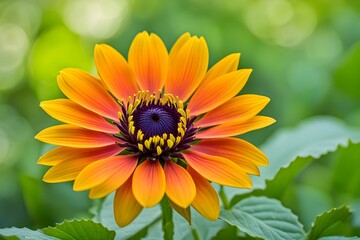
[36,32,275,226]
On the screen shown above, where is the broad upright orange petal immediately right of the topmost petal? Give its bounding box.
[165,37,209,102]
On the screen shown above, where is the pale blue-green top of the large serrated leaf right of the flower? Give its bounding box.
[261,117,360,187]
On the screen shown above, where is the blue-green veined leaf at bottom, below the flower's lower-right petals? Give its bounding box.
[220,197,305,240]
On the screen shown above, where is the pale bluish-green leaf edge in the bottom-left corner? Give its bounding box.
[0,227,57,240]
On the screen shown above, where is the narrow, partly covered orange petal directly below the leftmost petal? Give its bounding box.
[38,144,123,166]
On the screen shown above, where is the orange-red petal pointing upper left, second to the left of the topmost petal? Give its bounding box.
[57,69,121,121]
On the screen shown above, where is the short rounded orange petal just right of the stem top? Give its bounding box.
[164,161,196,208]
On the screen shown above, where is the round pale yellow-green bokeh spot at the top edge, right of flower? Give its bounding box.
[245,0,317,47]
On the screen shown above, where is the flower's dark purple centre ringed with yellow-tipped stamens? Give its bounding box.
[115,90,197,161]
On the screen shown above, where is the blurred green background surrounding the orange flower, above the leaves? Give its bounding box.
[0,0,360,228]
